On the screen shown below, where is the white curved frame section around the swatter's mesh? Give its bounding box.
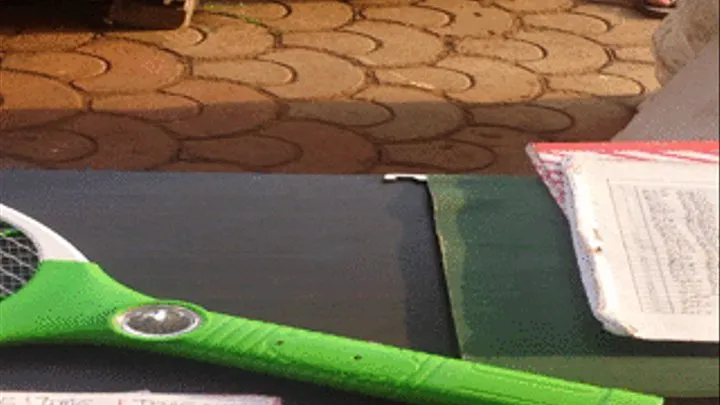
[0,204,89,262]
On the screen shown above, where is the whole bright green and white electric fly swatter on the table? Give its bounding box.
[0,205,662,405]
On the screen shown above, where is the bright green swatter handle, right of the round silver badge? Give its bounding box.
[146,313,662,405]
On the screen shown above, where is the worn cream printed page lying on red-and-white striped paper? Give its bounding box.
[566,155,720,342]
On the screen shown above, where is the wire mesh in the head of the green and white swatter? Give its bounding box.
[0,221,39,301]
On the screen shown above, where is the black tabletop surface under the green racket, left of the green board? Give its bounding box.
[0,171,717,405]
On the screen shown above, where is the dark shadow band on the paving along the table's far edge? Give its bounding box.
[0,96,631,174]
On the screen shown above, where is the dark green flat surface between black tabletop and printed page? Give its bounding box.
[429,176,720,397]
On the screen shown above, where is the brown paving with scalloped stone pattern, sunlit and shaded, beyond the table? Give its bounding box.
[0,0,658,174]
